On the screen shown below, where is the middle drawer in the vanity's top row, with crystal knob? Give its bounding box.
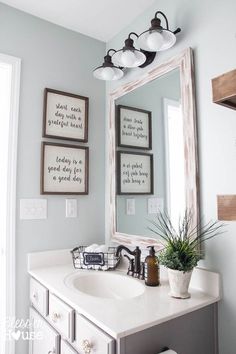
[49,294,74,341]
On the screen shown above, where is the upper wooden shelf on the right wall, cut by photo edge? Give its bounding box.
[212,69,236,110]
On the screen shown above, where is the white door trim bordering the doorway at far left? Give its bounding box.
[0,53,21,354]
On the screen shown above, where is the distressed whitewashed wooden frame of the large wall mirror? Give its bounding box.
[106,48,199,248]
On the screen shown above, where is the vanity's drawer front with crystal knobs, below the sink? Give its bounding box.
[29,278,116,354]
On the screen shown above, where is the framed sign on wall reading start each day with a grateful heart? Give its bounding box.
[43,88,89,142]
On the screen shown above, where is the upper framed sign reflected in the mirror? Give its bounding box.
[117,105,152,150]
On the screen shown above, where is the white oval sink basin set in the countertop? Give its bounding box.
[65,272,145,300]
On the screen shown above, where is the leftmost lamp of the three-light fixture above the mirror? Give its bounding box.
[93,49,124,81]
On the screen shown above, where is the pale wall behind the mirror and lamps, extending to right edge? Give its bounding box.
[107,0,236,354]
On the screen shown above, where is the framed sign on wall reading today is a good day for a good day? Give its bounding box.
[41,142,89,194]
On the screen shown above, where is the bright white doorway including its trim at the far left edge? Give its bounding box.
[0,53,20,354]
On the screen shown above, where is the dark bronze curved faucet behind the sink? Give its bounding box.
[116,245,143,279]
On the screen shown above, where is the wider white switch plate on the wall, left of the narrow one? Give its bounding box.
[20,199,47,220]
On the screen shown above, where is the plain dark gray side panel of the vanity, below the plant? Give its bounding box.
[117,300,218,354]
